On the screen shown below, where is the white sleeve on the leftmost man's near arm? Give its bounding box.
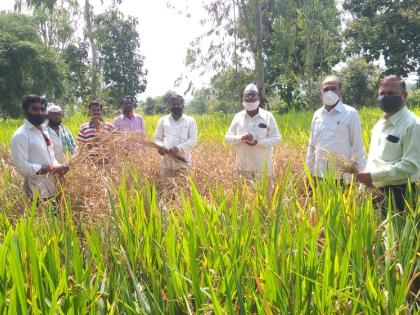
[11,134,42,177]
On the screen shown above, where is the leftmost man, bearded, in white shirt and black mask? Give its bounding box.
[11,95,68,199]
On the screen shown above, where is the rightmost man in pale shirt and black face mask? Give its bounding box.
[357,75,420,211]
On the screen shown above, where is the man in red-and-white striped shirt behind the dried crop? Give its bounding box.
[77,101,114,144]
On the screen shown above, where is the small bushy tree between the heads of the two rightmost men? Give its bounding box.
[338,56,383,106]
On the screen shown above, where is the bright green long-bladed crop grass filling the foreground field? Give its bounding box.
[0,105,420,314]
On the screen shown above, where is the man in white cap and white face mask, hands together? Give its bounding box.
[225,84,281,179]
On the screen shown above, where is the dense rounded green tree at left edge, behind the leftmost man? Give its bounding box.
[0,13,66,117]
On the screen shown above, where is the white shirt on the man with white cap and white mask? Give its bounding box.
[225,108,281,176]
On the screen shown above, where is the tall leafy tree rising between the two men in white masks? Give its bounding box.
[264,0,342,107]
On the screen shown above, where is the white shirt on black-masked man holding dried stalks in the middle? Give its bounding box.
[155,114,198,169]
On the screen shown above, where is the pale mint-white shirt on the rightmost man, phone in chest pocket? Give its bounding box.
[366,106,420,187]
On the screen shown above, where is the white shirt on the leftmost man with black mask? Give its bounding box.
[11,121,59,198]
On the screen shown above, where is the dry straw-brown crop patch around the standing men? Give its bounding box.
[0,130,303,222]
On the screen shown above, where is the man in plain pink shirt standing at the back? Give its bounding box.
[114,96,146,137]
